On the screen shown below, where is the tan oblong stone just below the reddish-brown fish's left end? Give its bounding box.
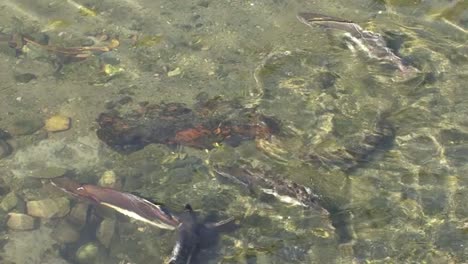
[26,197,70,218]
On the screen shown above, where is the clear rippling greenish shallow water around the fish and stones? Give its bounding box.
[0,1,468,263]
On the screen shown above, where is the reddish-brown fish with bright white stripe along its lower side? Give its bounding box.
[52,178,180,230]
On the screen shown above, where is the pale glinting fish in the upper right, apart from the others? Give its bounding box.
[297,13,419,74]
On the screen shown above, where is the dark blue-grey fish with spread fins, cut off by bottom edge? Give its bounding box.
[168,204,237,264]
